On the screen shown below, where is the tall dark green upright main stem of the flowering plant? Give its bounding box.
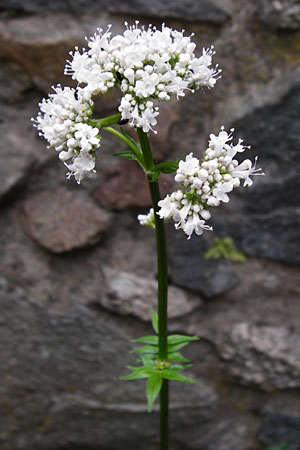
[137,128,169,450]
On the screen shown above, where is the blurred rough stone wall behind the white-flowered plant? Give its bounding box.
[0,0,300,450]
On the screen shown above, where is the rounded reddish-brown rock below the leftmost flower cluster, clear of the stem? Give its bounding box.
[23,188,109,253]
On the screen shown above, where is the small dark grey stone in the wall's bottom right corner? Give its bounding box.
[258,411,300,450]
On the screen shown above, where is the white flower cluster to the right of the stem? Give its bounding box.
[158,127,263,239]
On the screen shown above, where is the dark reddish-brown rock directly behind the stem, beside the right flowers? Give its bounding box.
[93,158,170,210]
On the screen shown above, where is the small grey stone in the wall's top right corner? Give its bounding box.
[258,0,300,30]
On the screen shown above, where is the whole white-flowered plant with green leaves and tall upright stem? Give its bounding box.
[33,22,262,450]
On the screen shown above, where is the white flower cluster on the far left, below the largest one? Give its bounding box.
[34,86,100,183]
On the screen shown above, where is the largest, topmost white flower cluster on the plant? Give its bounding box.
[65,22,220,132]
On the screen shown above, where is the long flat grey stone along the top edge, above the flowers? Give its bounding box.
[1,0,229,24]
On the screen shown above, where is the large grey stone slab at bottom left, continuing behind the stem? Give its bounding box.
[0,279,216,450]
